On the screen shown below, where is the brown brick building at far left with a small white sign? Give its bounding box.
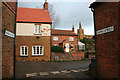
[0,0,17,79]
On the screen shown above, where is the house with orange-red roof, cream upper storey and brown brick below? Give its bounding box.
[16,2,52,61]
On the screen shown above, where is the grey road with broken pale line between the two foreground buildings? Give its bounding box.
[16,59,90,78]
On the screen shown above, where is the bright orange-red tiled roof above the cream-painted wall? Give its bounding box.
[17,7,52,23]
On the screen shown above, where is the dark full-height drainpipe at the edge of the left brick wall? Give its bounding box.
[13,0,18,80]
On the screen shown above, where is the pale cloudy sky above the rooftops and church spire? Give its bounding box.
[18,0,94,35]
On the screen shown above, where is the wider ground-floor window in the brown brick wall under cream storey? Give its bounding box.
[32,46,44,55]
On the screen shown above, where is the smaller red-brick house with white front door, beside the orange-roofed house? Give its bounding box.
[51,26,78,52]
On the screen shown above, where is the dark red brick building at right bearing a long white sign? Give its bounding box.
[90,2,120,80]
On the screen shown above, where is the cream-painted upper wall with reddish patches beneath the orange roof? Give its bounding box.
[16,23,51,36]
